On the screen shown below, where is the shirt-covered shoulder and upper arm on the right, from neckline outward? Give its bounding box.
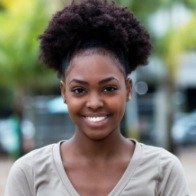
[135,143,189,196]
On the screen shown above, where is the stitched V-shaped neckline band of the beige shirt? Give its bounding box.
[53,140,142,196]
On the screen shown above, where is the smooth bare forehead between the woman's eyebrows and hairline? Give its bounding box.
[65,52,124,80]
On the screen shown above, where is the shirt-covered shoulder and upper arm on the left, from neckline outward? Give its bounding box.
[5,144,57,196]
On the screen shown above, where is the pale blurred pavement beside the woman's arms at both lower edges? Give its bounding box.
[0,146,196,196]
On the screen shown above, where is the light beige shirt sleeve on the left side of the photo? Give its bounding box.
[5,160,33,196]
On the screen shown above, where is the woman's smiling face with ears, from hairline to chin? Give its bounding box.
[61,53,131,140]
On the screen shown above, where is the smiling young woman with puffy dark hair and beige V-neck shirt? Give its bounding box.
[6,0,188,196]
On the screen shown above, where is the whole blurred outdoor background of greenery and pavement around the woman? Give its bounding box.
[0,0,196,195]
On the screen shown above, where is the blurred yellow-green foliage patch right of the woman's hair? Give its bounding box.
[152,15,196,79]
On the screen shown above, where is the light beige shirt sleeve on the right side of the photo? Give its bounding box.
[158,151,190,196]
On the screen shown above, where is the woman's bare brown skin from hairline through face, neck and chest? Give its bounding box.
[61,49,134,196]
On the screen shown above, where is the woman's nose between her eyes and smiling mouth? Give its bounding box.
[86,93,103,110]
